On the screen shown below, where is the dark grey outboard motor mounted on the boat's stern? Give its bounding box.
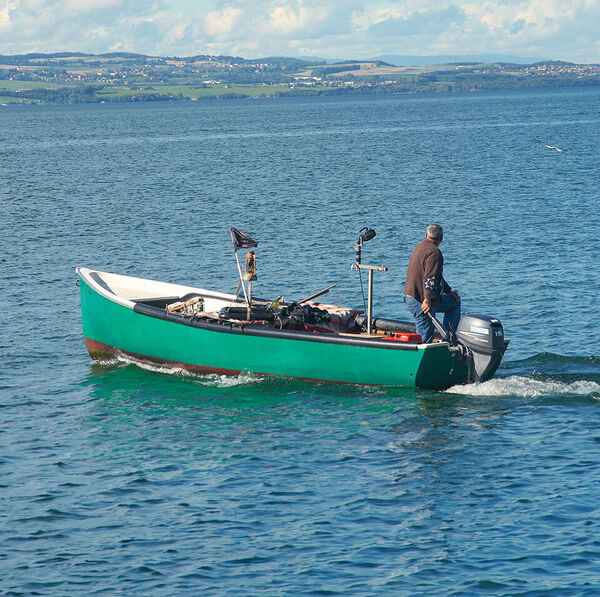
[456,315,508,382]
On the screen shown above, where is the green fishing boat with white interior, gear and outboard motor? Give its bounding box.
[77,229,507,389]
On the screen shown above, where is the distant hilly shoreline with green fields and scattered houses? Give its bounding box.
[0,53,600,104]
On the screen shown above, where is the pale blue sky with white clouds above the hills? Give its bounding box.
[0,0,600,63]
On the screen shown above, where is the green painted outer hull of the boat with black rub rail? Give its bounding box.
[79,273,467,389]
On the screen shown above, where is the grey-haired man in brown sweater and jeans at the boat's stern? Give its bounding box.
[404,224,460,342]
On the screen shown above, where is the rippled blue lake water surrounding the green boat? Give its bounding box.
[0,88,600,597]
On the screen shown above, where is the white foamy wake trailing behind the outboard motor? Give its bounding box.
[446,375,600,398]
